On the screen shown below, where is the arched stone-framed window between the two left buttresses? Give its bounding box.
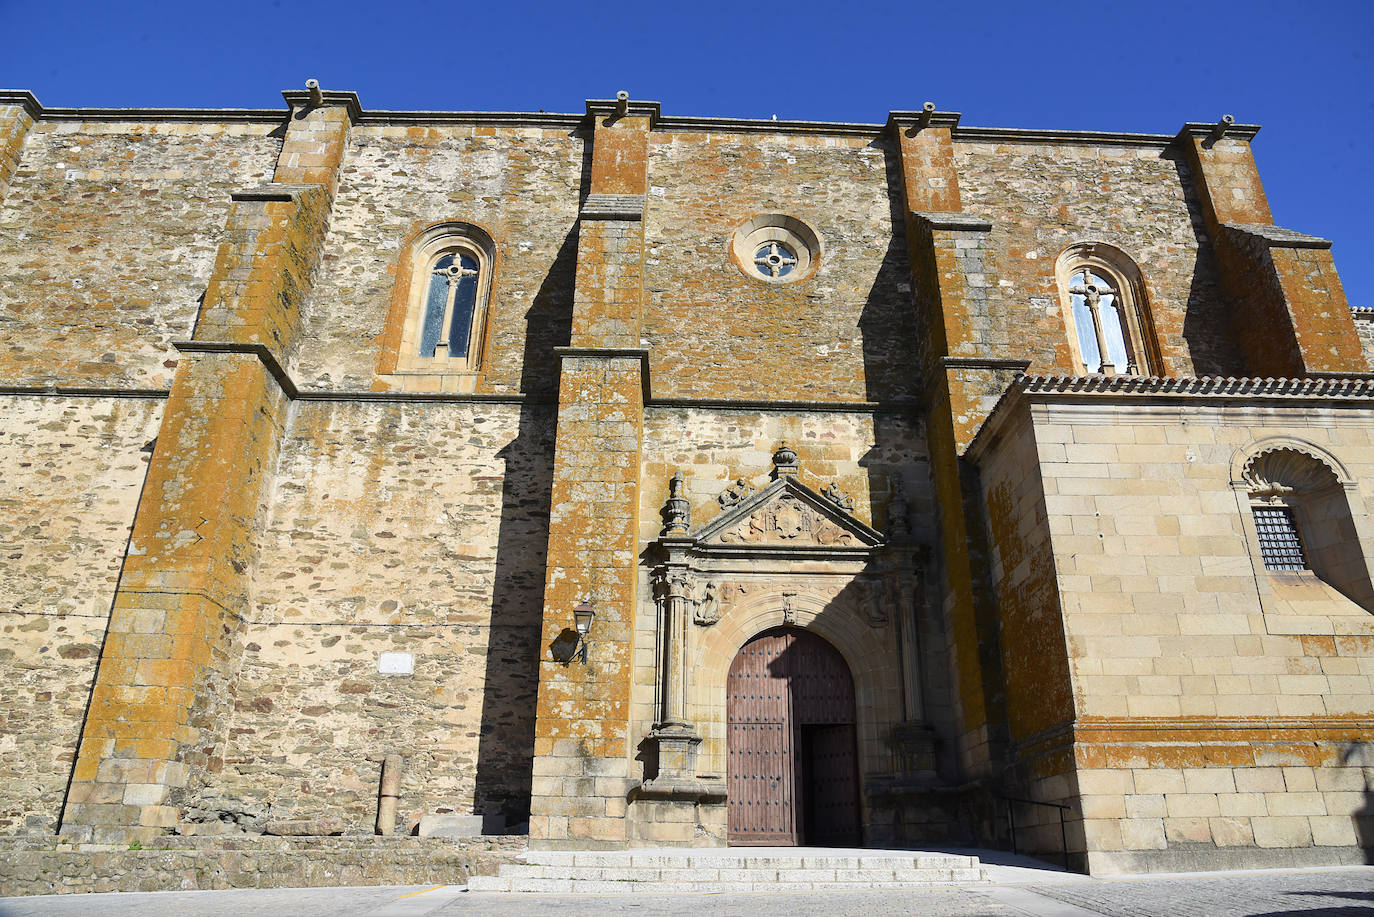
[396,223,495,374]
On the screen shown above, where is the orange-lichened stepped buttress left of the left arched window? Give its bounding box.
[60,93,356,843]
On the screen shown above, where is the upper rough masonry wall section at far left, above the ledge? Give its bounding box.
[0,121,280,388]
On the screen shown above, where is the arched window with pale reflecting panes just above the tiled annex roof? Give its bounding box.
[1057,243,1156,375]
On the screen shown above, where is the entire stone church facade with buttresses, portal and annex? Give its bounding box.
[0,84,1374,873]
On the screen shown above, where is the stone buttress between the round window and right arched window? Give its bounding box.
[888,103,1025,791]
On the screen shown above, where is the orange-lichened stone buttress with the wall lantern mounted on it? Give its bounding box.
[530,100,658,847]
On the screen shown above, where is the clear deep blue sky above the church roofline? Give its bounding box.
[0,0,1374,307]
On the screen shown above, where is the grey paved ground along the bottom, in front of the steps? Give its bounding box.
[0,868,1374,917]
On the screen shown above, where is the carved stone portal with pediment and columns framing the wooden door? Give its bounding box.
[633,445,925,843]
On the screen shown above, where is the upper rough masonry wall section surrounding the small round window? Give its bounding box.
[643,132,919,400]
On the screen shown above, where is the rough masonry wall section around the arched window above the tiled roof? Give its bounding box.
[955,143,1238,375]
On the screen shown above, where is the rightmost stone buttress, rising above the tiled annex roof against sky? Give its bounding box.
[1178,120,1370,377]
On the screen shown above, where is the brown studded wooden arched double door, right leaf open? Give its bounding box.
[725,627,861,847]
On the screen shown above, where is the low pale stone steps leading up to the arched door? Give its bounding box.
[467,847,988,894]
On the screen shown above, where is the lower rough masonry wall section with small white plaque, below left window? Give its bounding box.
[195,401,554,833]
